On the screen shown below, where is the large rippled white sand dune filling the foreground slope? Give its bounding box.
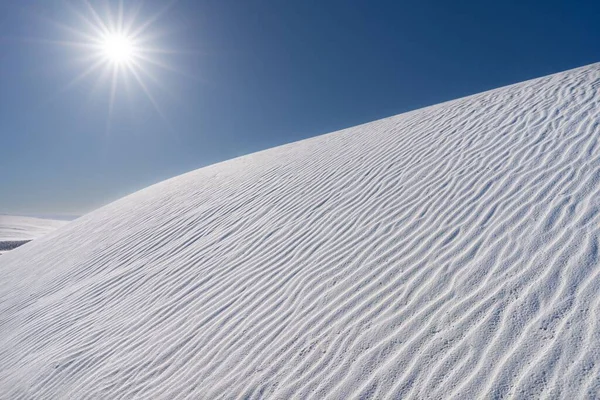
[0,64,600,399]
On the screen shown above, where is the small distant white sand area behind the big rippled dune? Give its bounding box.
[0,214,67,255]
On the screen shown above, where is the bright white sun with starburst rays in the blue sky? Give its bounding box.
[44,0,185,131]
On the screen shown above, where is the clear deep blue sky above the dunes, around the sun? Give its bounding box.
[0,0,600,219]
